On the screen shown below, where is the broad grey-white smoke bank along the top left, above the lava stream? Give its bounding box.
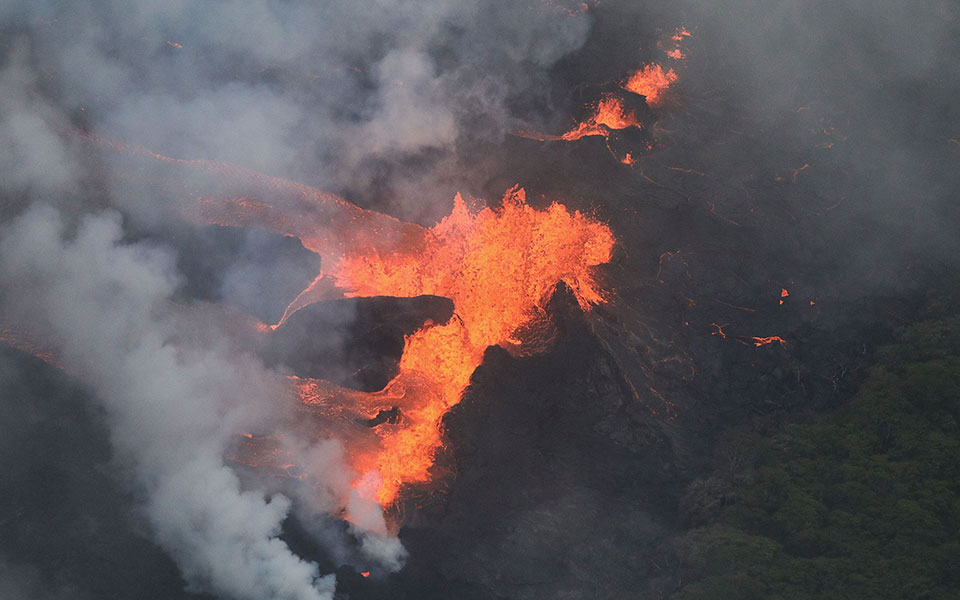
[0,0,590,220]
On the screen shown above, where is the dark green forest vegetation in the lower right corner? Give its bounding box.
[672,319,960,600]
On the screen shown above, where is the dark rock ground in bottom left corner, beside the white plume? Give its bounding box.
[0,346,213,600]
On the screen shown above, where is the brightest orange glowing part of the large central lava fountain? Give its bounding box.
[300,188,614,506]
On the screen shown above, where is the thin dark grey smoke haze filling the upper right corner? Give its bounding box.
[668,0,960,296]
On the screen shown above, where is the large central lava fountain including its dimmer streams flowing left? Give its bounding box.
[201,183,614,507]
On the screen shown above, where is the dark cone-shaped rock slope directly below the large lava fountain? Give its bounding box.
[351,286,679,600]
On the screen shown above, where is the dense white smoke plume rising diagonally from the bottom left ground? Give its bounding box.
[0,207,344,600]
